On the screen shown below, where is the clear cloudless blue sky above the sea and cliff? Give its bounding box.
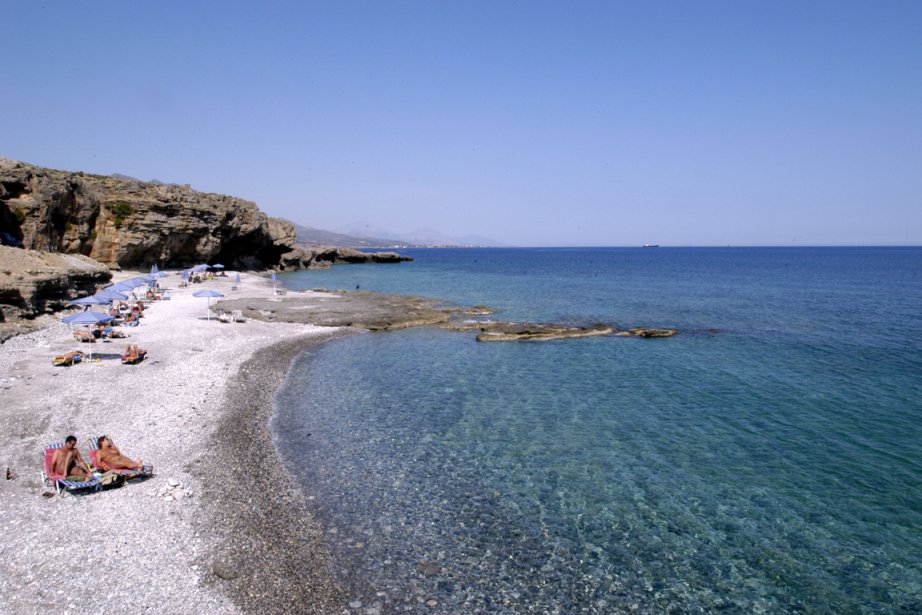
[0,0,922,246]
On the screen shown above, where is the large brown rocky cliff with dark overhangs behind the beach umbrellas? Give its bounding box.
[0,159,295,269]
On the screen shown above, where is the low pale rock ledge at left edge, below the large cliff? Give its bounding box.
[0,246,112,341]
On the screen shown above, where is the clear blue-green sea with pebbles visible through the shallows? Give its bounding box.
[272,247,922,613]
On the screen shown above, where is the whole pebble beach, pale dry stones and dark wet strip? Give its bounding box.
[0,272,350,614]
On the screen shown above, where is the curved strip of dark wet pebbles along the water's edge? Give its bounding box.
[194,329,356,613]
